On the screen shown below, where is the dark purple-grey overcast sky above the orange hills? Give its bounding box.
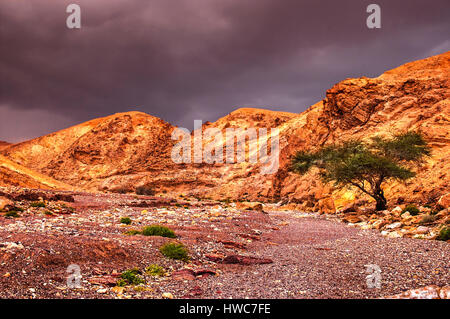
[0,0,450,142]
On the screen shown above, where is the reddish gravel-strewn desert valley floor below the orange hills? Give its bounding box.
[0,191,450,298]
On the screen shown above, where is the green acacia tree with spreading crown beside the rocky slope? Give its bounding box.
[291,131,431,210]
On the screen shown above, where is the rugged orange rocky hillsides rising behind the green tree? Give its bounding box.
[3,52,450,209]
